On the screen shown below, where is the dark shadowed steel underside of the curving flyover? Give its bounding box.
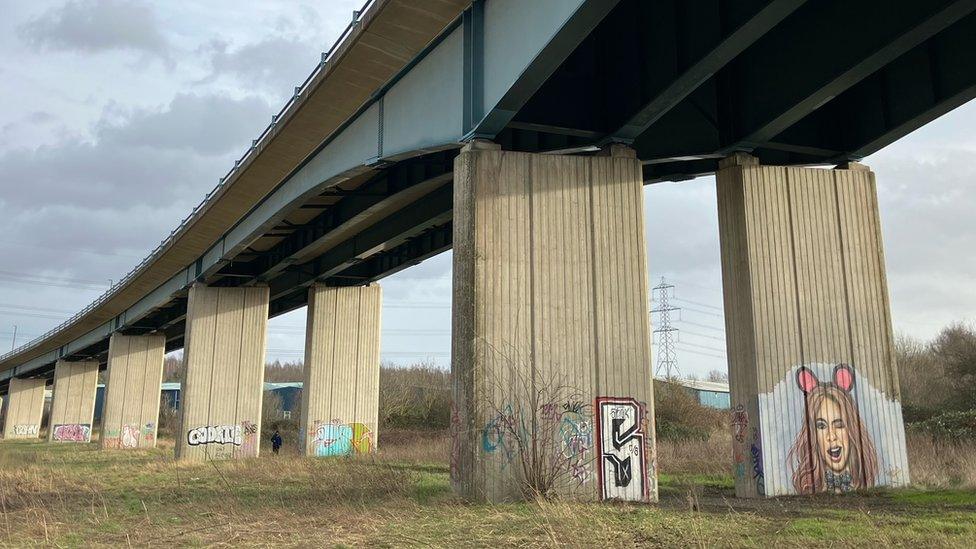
[0,0,976,406]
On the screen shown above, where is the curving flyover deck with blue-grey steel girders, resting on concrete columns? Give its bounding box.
[0,0,976,392]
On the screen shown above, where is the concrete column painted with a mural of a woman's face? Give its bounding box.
[717,153,908,497]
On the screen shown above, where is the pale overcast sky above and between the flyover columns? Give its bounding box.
[0,0,976,375]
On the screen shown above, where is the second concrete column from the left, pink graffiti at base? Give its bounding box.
[47,360,98,442]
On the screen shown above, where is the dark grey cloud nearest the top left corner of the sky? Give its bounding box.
[18,0,169,60]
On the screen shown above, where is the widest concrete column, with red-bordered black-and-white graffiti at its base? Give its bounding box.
[451,142,657,501]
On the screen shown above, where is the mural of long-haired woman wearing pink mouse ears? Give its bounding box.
[787,364,878,494]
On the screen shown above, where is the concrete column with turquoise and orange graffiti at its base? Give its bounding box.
[301,284,382,456]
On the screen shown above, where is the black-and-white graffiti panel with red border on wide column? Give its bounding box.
[596,397,650,501]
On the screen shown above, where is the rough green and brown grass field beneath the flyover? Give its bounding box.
[0,433,976,547]
